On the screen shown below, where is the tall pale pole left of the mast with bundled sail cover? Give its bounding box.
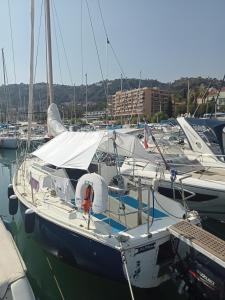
[27,0,34,150]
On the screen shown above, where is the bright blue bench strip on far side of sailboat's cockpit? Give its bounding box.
[110,192,167,218]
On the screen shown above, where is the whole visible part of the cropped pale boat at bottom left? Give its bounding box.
[0,219,35,300]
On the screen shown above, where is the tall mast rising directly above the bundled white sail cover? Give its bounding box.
[45,0,53,104]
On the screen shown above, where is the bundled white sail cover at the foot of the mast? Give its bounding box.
[47,103,67,137]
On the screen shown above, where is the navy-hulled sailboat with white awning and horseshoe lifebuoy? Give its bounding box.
[13,0,225,299]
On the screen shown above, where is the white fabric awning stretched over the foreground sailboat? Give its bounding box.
[33,131,154,170]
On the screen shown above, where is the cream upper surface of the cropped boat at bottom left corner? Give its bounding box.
[0,219,26,299]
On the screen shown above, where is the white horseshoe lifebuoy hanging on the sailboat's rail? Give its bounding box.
[75,173,108,214]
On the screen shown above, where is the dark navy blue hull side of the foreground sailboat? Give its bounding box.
[20,202,125,281]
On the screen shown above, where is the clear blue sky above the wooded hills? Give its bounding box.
[0,0,225,85]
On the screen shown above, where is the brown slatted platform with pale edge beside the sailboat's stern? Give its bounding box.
[168,221,225,267]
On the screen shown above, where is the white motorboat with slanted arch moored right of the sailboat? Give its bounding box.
[136,117,225,221]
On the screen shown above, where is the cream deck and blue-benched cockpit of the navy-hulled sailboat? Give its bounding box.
[14,160,184,239]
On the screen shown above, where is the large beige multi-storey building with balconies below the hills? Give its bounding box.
[108,87,171,117]
